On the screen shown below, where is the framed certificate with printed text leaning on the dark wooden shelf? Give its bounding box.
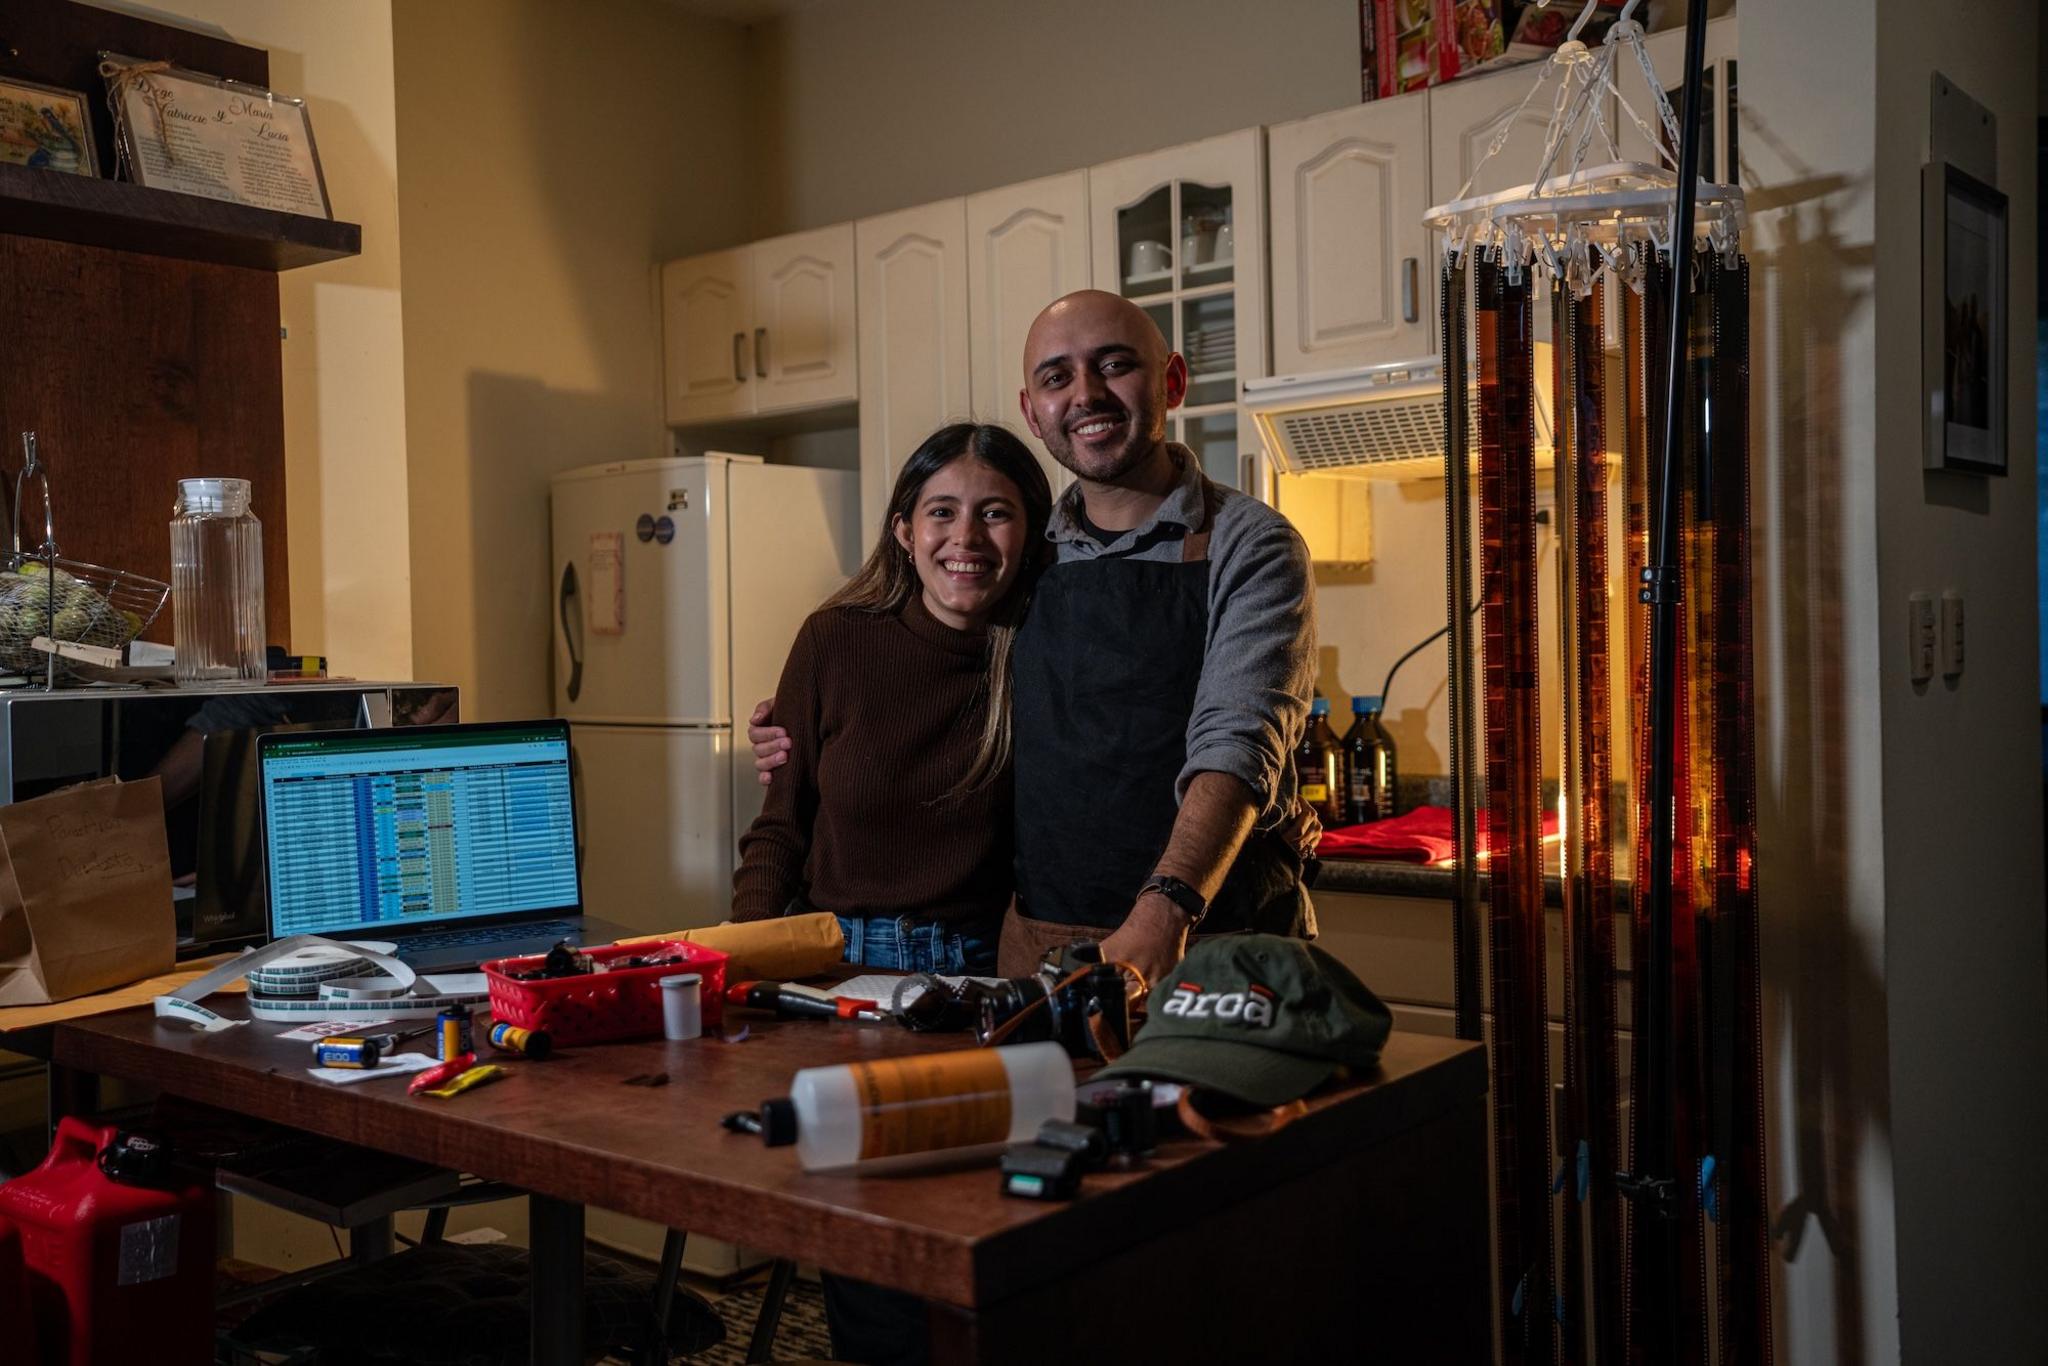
[100,53,334,219]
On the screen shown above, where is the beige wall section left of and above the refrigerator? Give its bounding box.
[395,0,754,721]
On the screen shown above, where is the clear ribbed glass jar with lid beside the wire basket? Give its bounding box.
[170,479,268,684]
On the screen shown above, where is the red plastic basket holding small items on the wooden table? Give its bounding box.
[483,940,727,1044]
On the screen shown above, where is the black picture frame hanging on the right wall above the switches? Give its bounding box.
[1921,162,2011,475]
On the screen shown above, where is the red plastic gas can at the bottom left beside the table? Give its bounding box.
[0,1118,213,1366]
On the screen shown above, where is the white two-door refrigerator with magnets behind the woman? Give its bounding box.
[551,455,860,932]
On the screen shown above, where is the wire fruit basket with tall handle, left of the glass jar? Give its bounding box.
[0,432,170,684]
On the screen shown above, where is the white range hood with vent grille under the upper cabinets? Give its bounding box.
[1243,352,1550,479]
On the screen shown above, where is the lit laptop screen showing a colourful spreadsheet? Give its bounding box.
[260,721,580,938]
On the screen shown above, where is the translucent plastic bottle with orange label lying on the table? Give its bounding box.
[788,1042,1073,1171]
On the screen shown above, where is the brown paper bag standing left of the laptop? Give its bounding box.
[0,778,178,1006]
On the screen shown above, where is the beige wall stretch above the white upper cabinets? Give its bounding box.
[748,0,1358,236]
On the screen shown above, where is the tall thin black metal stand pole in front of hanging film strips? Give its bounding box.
[1622,0,1706,1362]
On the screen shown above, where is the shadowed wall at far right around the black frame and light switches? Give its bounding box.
[1875,0,2048,1362]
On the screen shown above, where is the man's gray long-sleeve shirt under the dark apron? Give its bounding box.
[1044,442,1315,829]
